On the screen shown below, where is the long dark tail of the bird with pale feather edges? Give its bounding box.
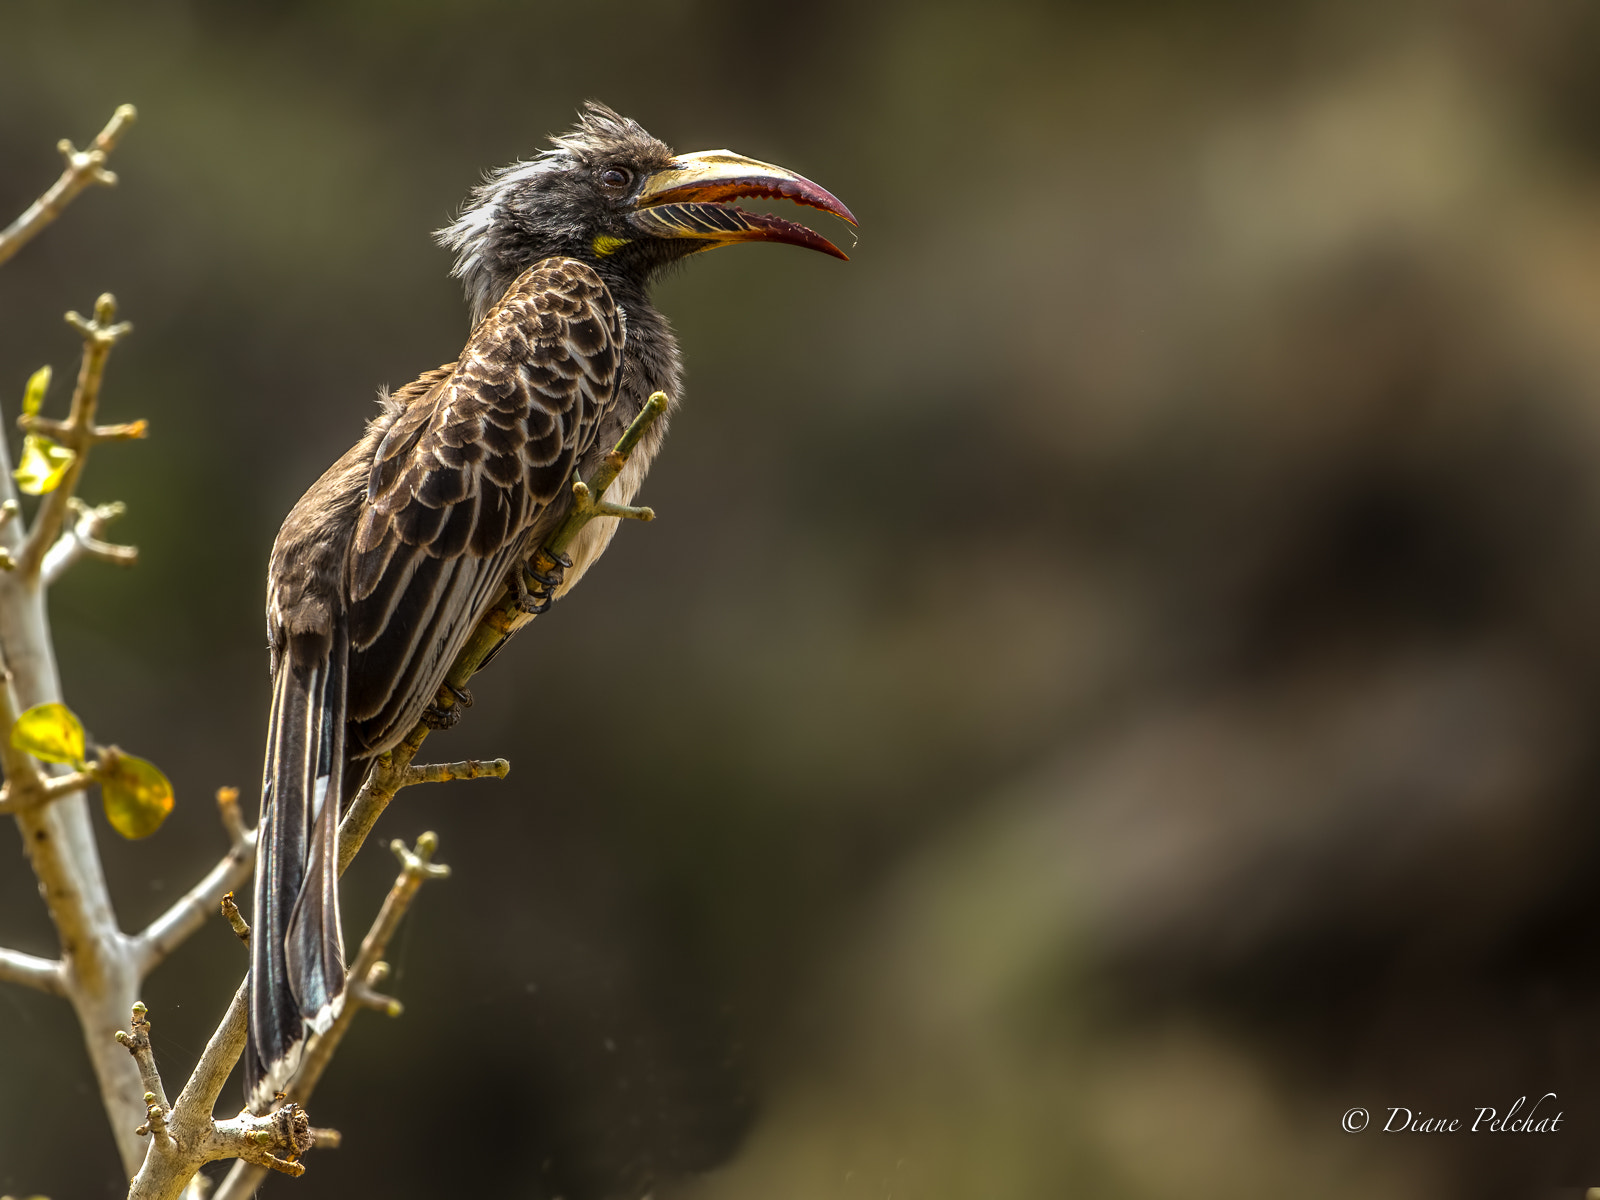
[245,622,349,1109]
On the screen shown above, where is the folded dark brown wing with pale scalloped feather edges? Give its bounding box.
[346,259,622,755]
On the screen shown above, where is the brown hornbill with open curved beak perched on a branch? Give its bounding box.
[245,101,856,1112]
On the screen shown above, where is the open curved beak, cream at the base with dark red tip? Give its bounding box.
[629,150,856,259]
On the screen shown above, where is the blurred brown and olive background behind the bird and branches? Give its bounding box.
[0,0,1600,1200]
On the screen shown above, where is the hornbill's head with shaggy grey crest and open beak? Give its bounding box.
[437,101,856,322]
